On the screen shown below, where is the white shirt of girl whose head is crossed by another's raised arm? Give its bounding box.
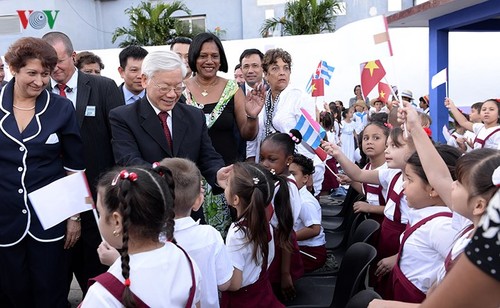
[399,206,457,293]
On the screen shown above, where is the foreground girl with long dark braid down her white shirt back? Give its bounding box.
[81,167,201,307]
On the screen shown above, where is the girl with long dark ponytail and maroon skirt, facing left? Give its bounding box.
[221,163,286,308]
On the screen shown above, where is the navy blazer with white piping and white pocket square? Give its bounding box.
[0,78,84,247]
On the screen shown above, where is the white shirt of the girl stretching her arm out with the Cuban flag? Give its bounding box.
[378,168,409,224]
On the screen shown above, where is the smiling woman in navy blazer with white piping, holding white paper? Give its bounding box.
[0,37,84,307]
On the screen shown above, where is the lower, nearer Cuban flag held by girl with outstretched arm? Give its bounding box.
[295,108,327,161]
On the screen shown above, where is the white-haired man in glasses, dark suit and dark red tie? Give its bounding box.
[109,51,227,192]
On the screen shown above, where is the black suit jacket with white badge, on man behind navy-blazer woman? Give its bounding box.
[54,71,123,196]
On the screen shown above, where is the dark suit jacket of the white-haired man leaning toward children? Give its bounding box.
[109,97,224,187]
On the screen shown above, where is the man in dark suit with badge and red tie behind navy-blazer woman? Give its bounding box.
[43,32,123,295]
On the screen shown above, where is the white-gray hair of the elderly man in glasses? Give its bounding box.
[142,50,187,79]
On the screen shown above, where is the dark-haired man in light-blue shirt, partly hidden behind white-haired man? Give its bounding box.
[118,45,148,105]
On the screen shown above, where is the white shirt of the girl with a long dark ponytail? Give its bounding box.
[226,222,274,287]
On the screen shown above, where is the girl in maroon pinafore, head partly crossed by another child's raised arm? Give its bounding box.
[382,145,461,303]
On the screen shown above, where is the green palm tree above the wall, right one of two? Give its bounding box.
[260,0,341,37]
